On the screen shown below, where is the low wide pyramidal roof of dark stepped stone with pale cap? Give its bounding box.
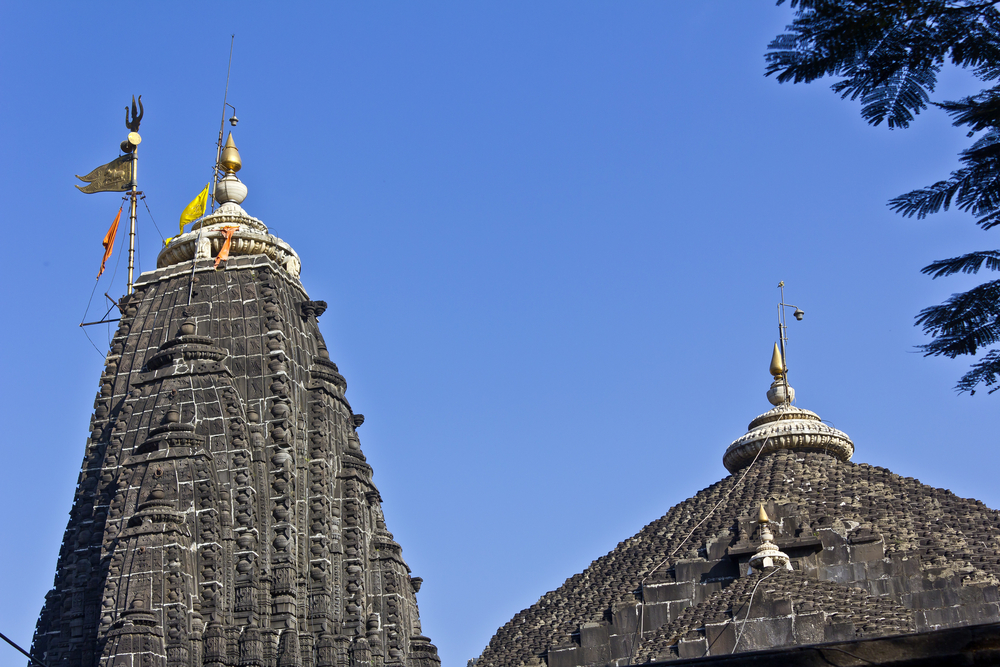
[477,376,1000,667]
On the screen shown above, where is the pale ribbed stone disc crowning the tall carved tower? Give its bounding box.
[156,203,302,278]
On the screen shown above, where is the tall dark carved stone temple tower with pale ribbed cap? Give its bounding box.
[32,150,440,667]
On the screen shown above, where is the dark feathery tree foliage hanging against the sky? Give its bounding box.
[765,0,1000,394]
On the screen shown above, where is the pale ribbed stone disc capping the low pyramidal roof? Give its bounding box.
[722,405,854,472]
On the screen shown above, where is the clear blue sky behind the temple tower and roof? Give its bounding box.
[0,0,1000,667]
